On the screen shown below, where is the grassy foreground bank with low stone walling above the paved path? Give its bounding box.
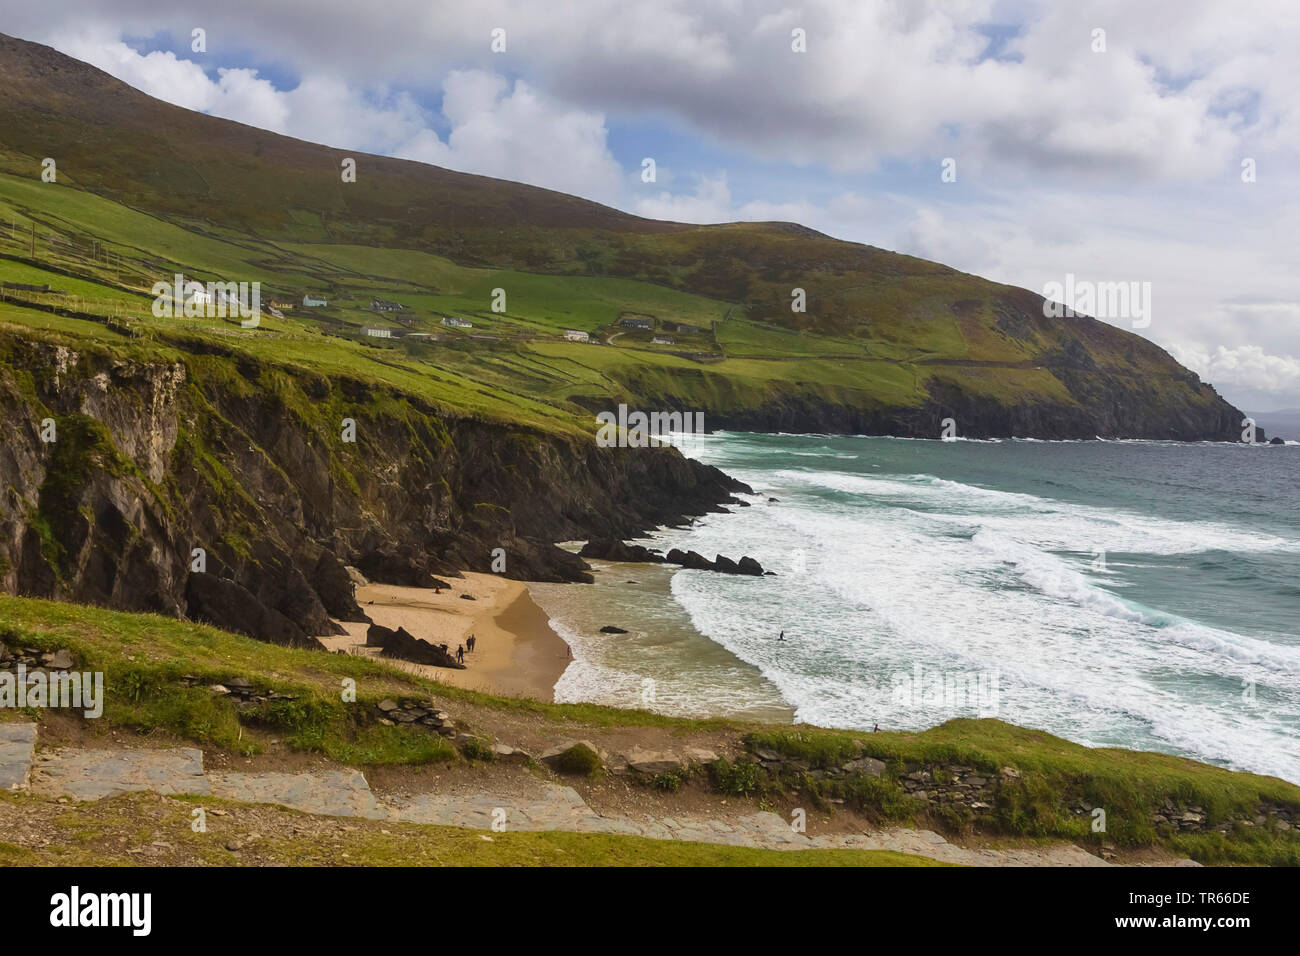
[0,596,1300,865]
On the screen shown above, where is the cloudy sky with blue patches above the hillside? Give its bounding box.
[0,0,1300,411]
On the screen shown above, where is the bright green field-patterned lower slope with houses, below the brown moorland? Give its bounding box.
[0,174,935,428]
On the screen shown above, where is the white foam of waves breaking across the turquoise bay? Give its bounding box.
[551,437,1300,780]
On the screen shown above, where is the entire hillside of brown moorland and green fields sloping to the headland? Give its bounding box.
[0,36,1240,440]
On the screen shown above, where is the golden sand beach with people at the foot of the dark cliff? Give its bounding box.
[320,571,571,701]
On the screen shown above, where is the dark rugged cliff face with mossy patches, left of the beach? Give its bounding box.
[0,339,744,645]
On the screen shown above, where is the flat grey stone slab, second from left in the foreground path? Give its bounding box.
[31,747,209,800]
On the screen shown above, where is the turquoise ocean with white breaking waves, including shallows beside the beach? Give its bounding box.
[534,433,1300,783]
